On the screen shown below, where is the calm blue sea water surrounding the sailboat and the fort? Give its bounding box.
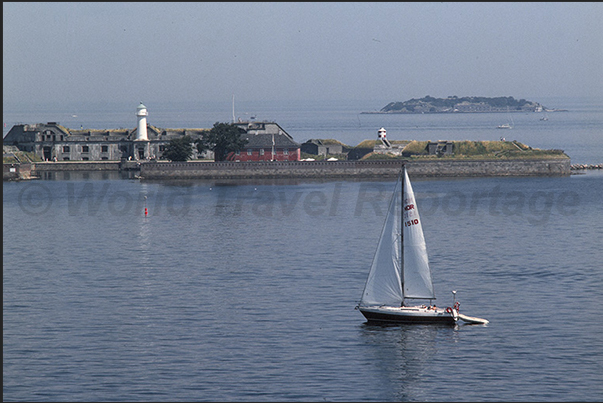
[3,98,603,401]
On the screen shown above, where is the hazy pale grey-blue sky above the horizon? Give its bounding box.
[3,2,603,106]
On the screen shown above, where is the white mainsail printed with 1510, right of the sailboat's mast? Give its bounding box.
[402,167,435,299]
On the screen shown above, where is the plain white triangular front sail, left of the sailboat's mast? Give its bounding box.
[360,176,402,306]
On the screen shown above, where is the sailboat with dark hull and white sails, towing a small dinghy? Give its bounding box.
[356,166,488,325]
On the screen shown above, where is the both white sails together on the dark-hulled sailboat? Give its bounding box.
[360,167,435,306]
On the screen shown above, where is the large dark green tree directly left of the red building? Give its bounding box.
[196,122,247,161]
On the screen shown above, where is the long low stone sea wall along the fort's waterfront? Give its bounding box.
[4,158,573,180]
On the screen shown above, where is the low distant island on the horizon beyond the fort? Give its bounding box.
[361,95,555,113]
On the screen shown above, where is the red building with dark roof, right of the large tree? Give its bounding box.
[227,121,301,161]
